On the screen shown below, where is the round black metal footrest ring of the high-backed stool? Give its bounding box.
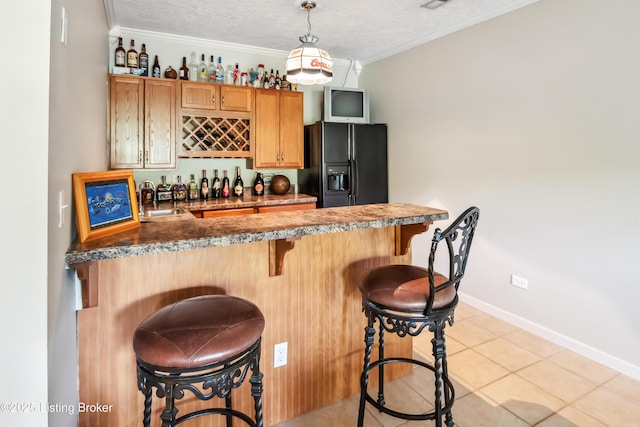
[360,357,455,421]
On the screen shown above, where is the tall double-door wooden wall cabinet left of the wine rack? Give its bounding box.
[109,75,177,169]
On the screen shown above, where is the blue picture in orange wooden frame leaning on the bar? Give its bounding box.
[72,170,140,243]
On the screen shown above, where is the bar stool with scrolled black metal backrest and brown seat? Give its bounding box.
[358,207,480,427]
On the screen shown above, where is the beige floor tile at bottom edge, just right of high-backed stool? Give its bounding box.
[452,393,529,427]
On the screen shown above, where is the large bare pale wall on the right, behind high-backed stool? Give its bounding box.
[360,0,640,378]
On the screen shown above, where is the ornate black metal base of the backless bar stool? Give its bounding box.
[137,340,263,427]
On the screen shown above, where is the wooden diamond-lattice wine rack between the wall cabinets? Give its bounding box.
[179,115,251,158]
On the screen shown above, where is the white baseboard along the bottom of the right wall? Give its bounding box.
[460,292,640,380]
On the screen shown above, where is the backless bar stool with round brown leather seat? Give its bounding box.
[133,295,265,427]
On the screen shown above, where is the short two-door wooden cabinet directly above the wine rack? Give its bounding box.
[181,82,253,113]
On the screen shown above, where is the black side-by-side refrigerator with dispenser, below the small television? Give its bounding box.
[298,122,389,208]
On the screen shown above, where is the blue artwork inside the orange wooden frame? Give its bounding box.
[85,179,133,230]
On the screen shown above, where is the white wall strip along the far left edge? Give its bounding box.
[0,0,50,427]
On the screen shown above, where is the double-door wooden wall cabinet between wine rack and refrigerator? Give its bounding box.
[252,89,304,169]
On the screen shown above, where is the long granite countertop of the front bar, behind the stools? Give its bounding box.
[65,204,448,265]
